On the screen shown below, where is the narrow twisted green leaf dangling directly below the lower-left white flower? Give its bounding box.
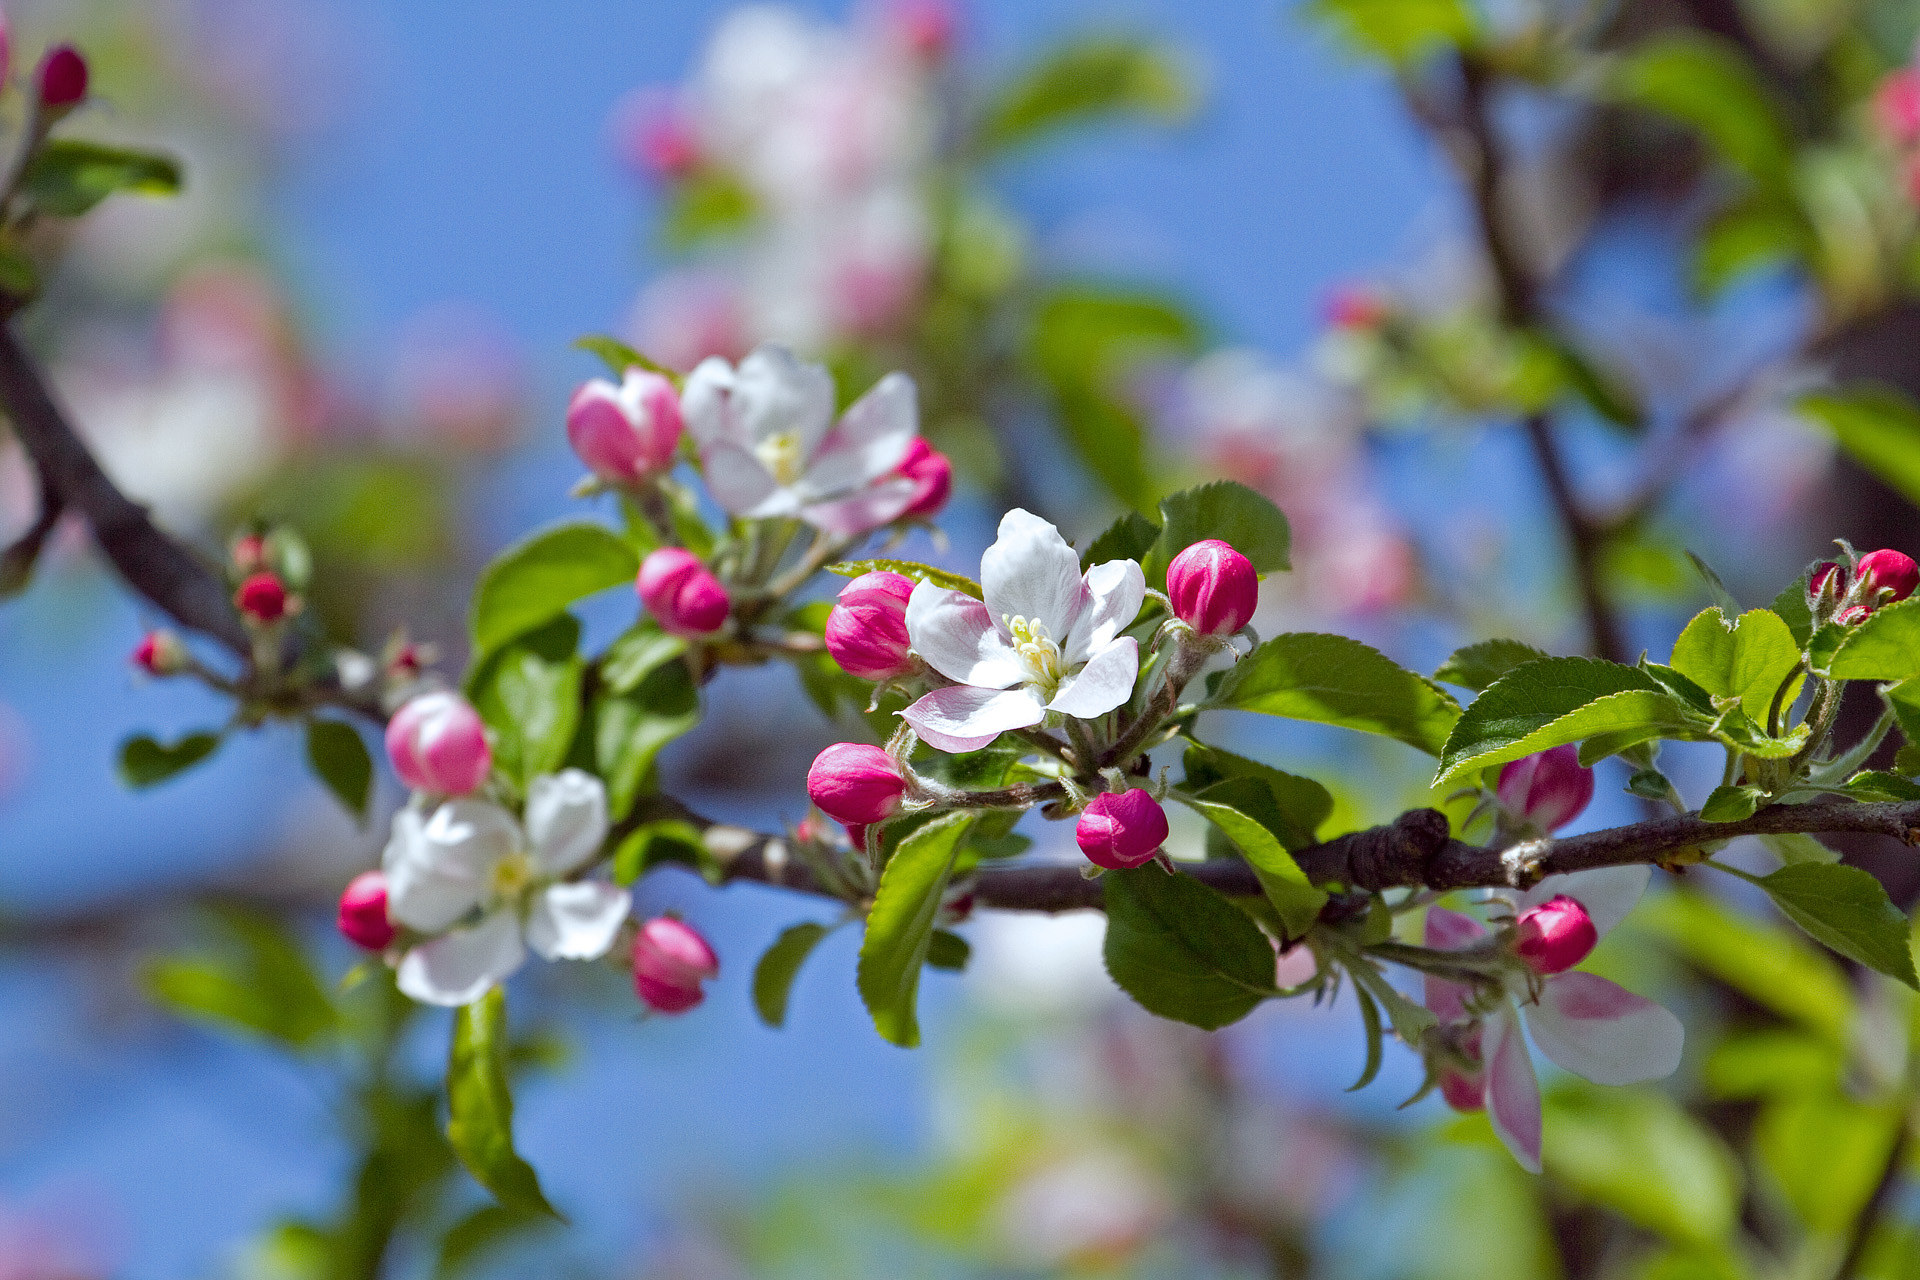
[447,986,566,1222]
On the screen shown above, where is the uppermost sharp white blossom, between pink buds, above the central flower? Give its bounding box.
[680,345,920,537]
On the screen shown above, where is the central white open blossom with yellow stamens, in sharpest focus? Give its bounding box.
[900,507,1146,752]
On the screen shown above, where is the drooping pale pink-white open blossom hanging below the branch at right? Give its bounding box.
[1427,865,1686,1173]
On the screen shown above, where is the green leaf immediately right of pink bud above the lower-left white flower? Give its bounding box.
[472,614,586,787]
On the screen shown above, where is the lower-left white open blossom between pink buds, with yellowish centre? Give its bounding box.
[382,770,632,1006]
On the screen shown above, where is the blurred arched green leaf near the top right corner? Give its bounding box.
[1611,33,1793,192]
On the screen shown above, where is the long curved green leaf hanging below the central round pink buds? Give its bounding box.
[860,814,972,1048]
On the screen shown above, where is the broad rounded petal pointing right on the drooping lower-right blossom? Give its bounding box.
[1526,969,1686,1084]
